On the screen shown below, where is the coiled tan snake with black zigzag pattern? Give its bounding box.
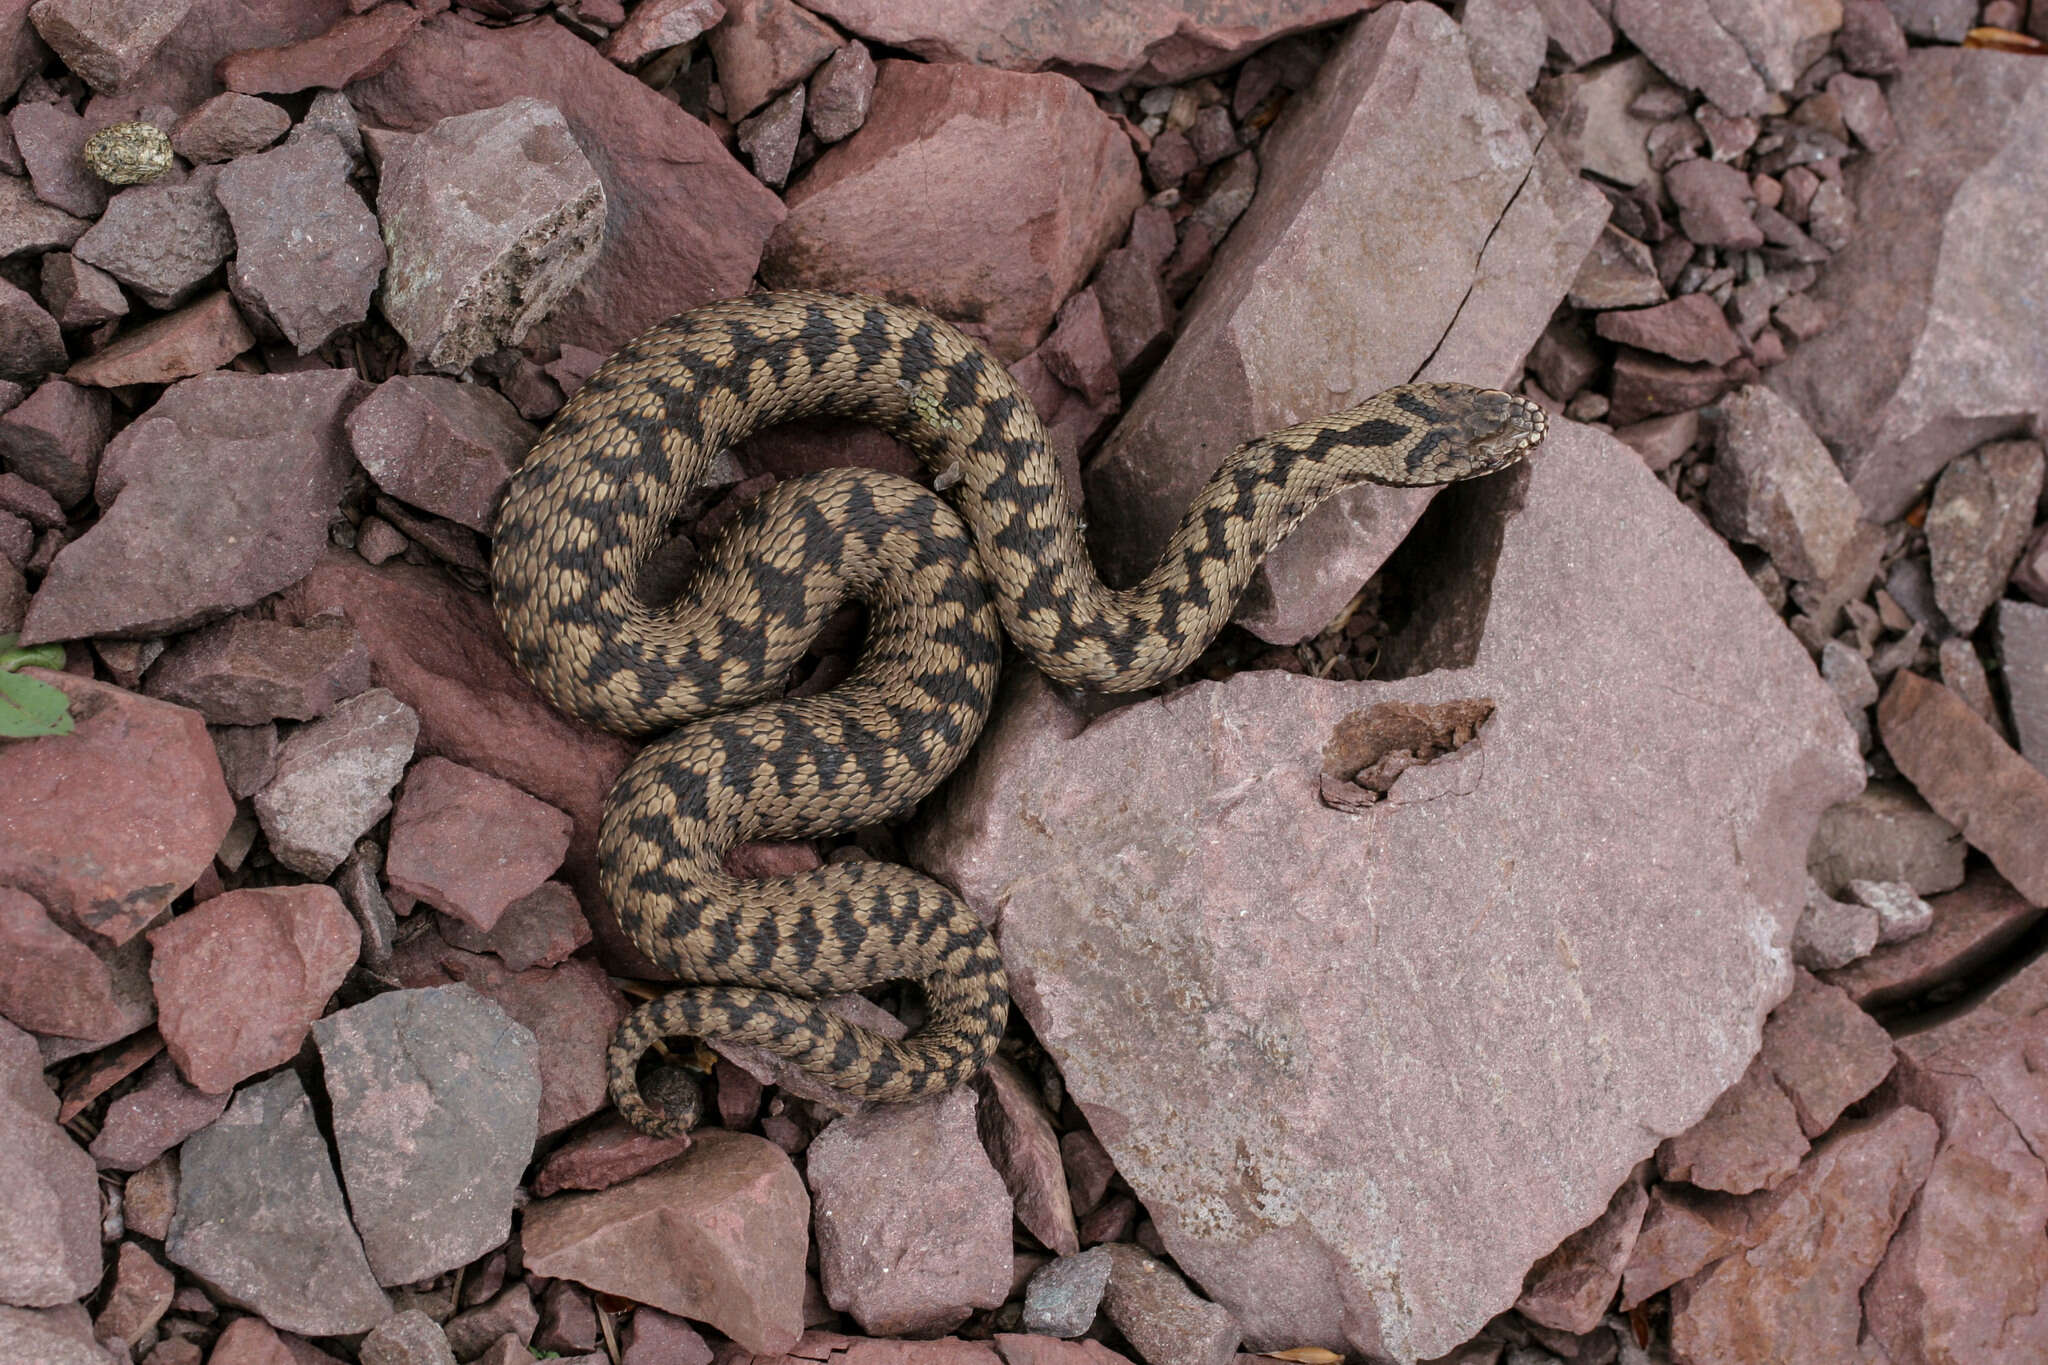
[489,291,1544,1136]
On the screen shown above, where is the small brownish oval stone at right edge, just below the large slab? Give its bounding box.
[1927,440,2044,634]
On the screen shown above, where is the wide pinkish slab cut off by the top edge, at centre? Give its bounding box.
[809,0,1374,90]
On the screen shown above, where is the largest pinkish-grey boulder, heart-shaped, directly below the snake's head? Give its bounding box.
[911,424,1862,1357]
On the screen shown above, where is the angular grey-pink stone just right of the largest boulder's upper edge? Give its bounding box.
[1706,385,1872,583]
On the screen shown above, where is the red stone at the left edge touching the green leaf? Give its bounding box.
[0,669,236,943]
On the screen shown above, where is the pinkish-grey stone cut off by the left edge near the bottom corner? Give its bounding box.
[0,1019,104,1309]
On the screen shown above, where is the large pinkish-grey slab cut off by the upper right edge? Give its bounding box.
[1769,47,2048,520]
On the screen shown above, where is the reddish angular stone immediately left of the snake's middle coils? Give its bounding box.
[385,757,569,933]
